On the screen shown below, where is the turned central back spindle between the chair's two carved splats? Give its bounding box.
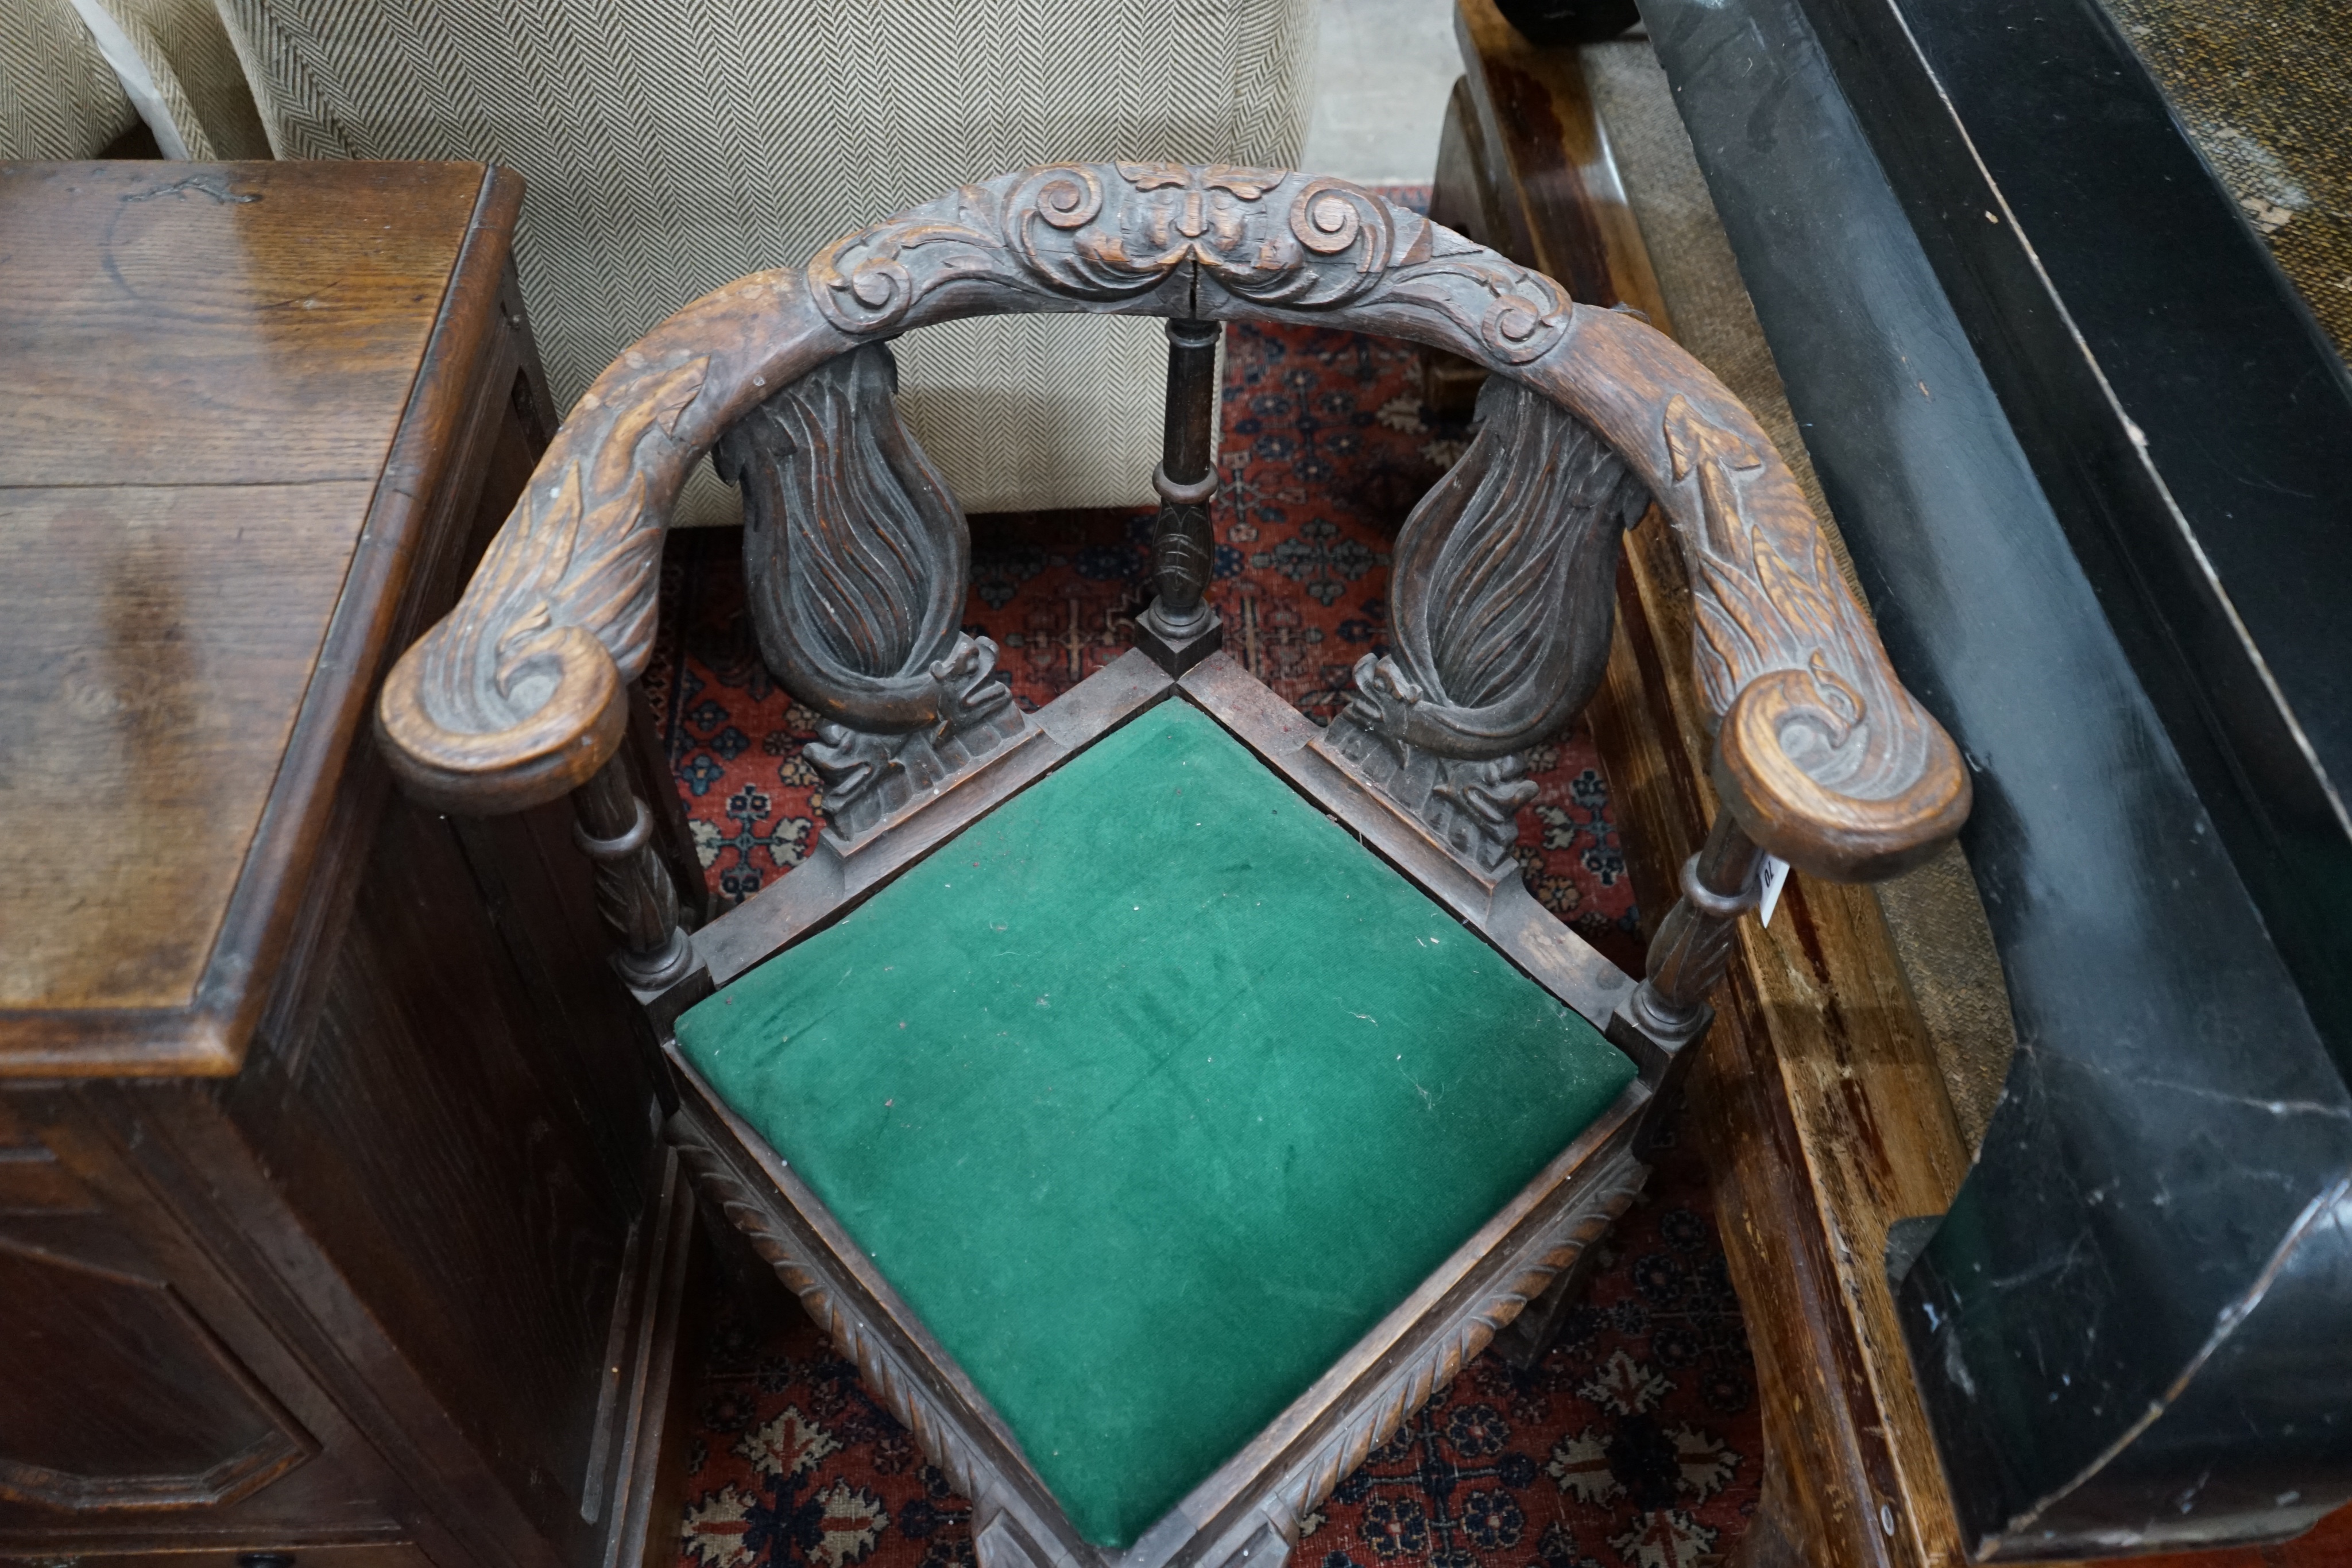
[1136,318,1225,675]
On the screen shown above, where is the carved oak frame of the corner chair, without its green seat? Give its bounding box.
[378,165,1968,1568]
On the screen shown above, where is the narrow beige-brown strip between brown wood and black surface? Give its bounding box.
[1583,40,2018,1149]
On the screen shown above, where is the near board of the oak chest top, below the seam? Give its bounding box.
[0,479,374,1011]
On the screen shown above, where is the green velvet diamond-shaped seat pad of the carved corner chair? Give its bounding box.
[678,698,1635,1547]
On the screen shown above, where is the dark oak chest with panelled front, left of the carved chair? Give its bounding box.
[0,165,694,1568]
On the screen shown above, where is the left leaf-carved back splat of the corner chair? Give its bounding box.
[715,343,1026,844]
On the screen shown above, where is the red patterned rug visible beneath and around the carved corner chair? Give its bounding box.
[644,196,1762,1568]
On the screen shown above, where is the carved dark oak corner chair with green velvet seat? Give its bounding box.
[378,165,1968,1568]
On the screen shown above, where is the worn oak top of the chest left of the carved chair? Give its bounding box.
[0,162,513,1074]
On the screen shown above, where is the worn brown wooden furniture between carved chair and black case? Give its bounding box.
[1430,21,1968,1568]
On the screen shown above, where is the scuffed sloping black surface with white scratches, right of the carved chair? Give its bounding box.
[1644,0,2352,1557]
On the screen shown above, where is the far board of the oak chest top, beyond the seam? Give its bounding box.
[0,162,482,484]
